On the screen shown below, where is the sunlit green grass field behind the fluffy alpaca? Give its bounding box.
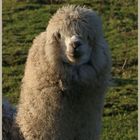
[2,0,138,140]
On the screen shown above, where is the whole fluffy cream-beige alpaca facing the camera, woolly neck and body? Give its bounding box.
[2,5,111,140]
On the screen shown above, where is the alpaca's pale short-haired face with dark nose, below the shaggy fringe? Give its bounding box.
[53,33,92,65]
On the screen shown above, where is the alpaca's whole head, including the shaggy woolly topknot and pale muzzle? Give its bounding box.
[44,6,102,65]
